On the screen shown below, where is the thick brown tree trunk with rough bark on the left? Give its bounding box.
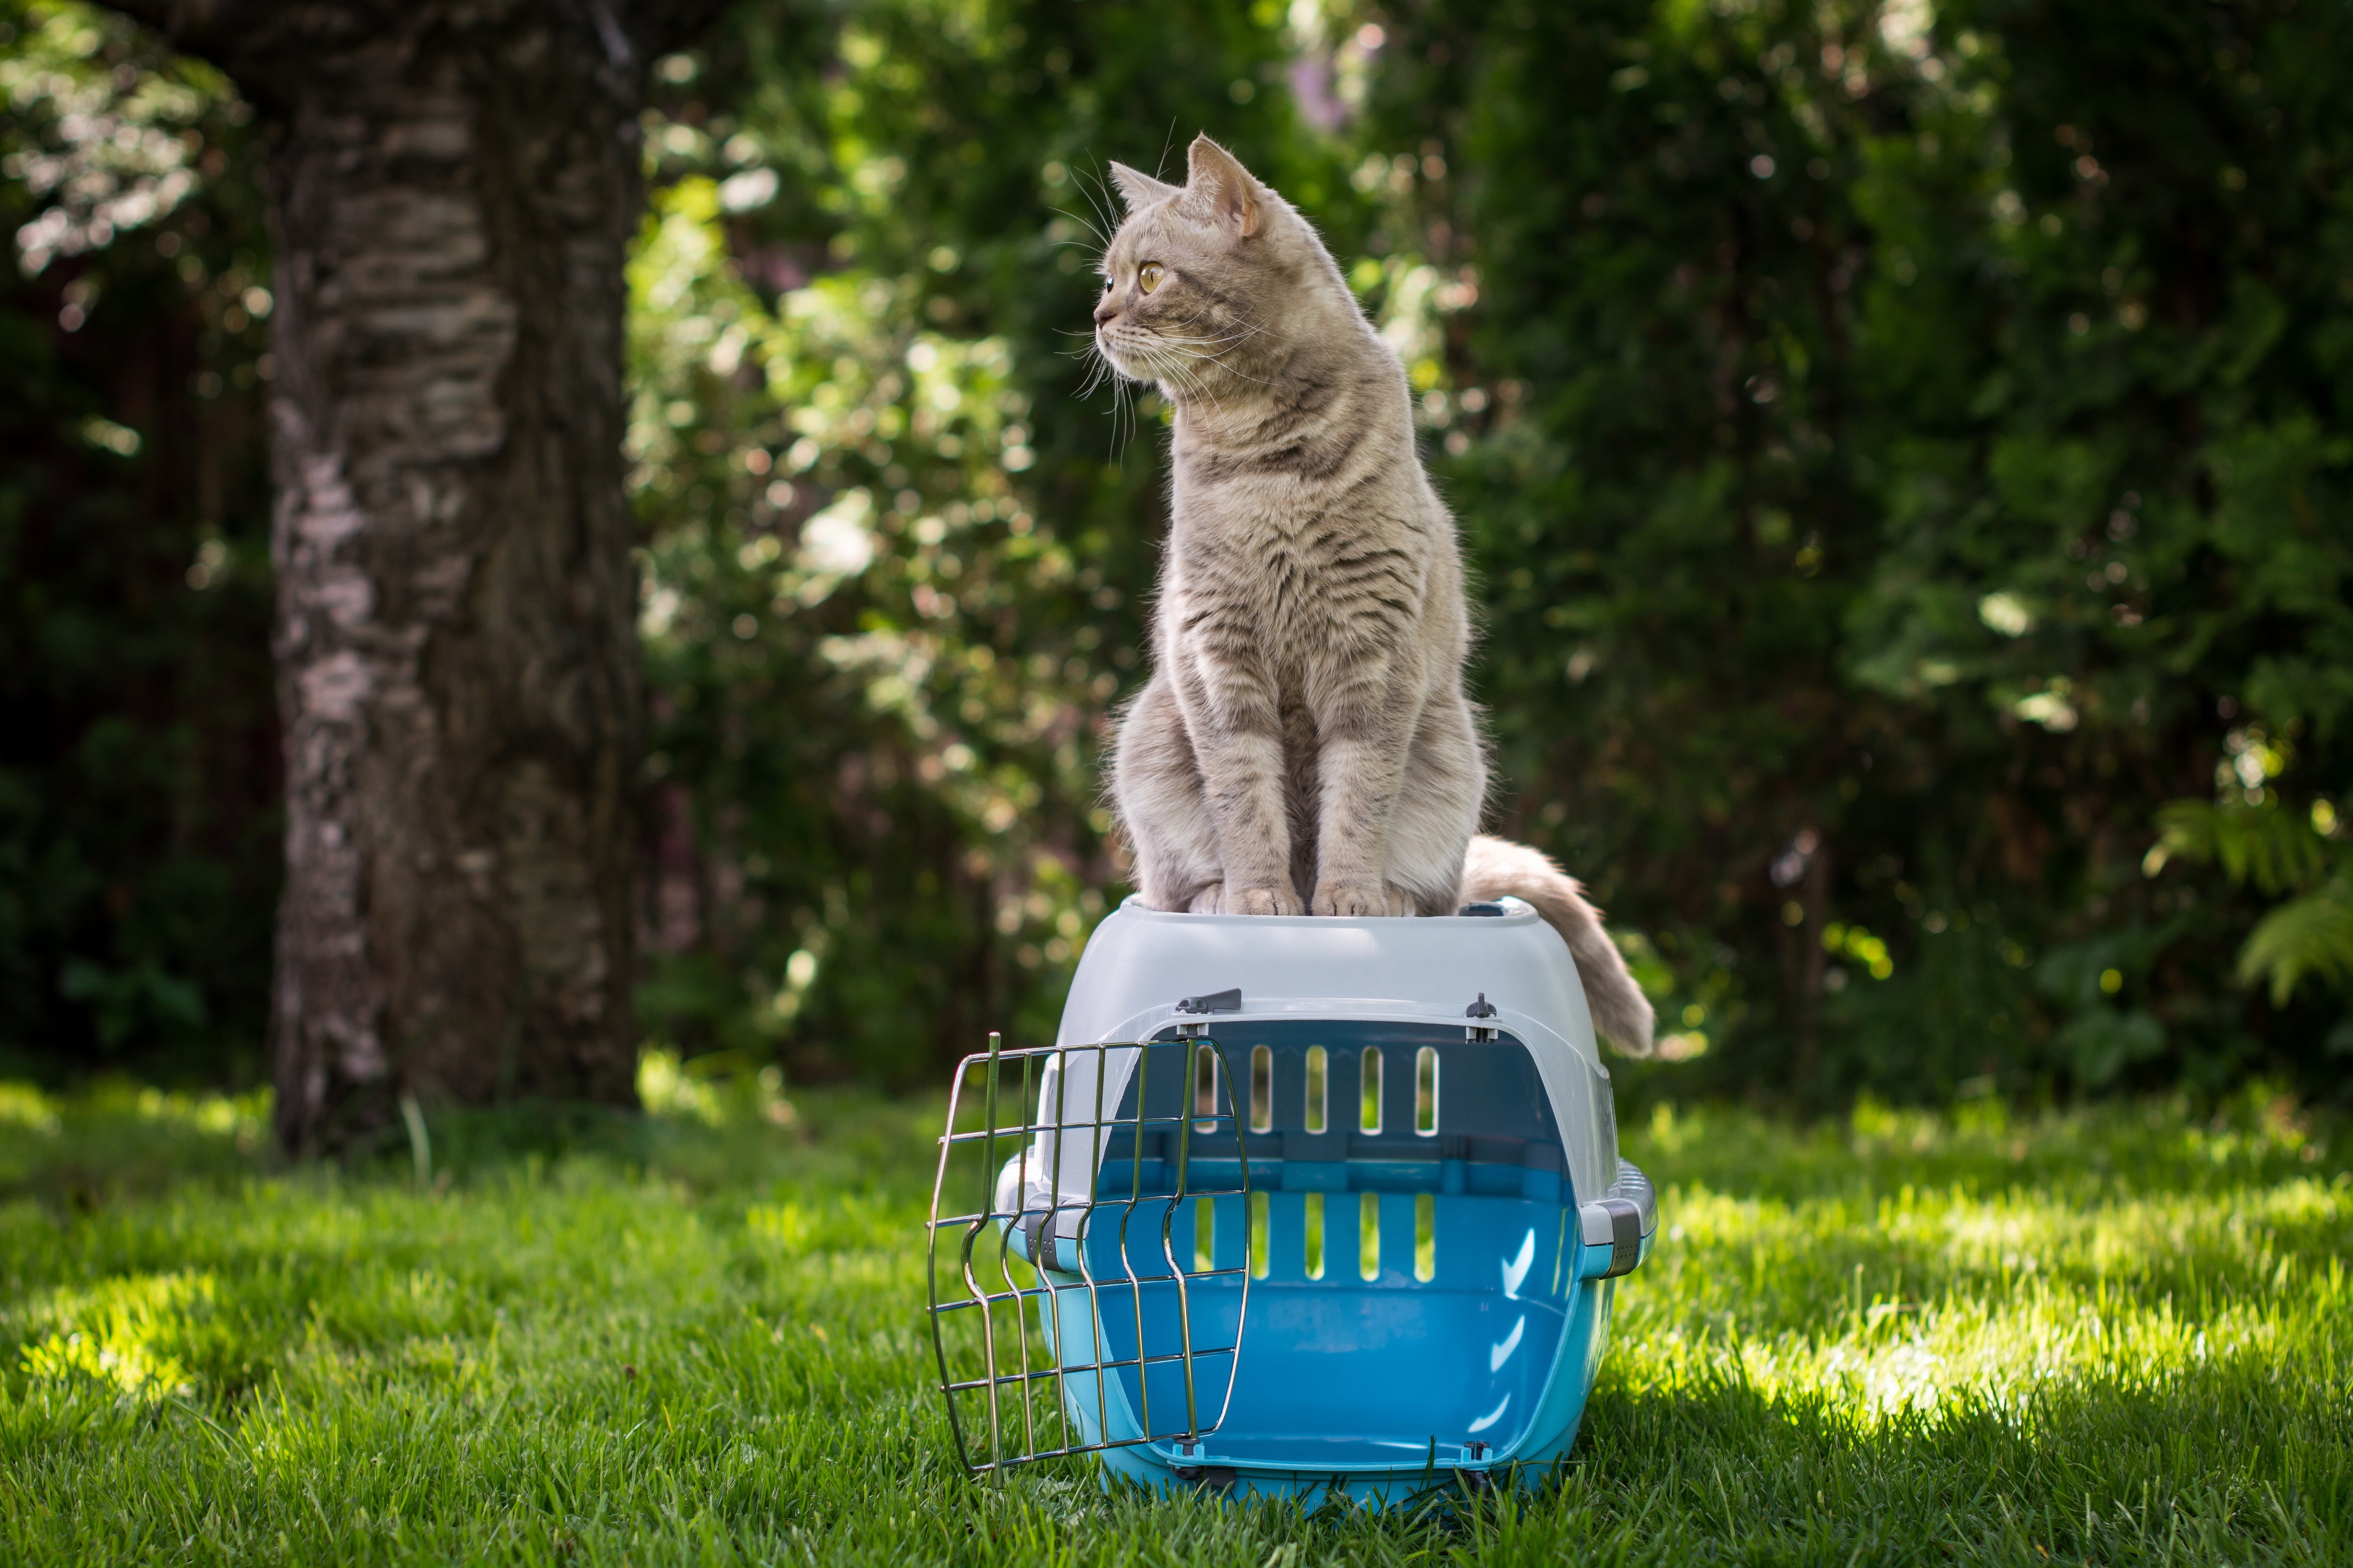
[125,0,715,1152]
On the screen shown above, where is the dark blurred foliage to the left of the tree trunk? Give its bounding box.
[0,0,278,1079]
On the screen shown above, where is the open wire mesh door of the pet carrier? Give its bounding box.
[927,1034,1250,1474]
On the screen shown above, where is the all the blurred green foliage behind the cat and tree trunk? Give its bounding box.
[0,0,2353,1103]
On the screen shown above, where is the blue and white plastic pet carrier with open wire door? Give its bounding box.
[930,900,1657,1497]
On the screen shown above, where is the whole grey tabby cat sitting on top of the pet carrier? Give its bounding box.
[1094,136,1652,1056]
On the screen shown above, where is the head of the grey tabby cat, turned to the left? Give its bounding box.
[1094,136,1355,400]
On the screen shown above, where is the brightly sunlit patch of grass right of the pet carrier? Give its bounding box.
[1612,1178,2353,1417]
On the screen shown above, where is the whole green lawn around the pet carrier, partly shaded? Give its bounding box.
[0,1079,2353,1568]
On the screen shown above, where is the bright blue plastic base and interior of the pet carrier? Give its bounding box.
[1014,1020,1657,1502]
